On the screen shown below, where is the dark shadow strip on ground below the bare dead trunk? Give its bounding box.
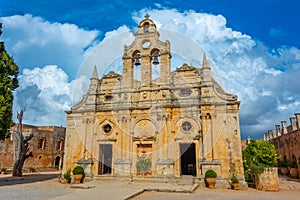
[0,173,59,186]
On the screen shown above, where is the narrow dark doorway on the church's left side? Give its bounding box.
[98,144,112,175]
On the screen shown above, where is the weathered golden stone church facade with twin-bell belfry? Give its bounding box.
[64,15,244,182]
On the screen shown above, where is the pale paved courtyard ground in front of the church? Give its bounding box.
[0,172,300,200]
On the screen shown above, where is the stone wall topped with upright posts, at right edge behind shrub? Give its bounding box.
[264,113,300,163]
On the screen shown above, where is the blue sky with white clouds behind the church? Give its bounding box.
[0,0,300,138]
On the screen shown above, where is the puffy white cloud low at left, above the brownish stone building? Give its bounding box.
[14,65,89,126]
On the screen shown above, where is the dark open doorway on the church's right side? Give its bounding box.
[179,143,197,176]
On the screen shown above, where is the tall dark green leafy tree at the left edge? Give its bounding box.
[0,23,19,140]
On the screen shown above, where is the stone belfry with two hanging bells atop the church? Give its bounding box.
[123,14,171,88]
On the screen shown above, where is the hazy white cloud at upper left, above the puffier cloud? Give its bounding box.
[0,14,99,78]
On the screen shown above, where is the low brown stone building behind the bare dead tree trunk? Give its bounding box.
[0,124,66,171]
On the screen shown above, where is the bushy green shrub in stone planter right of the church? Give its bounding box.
[243,140,279,181]
